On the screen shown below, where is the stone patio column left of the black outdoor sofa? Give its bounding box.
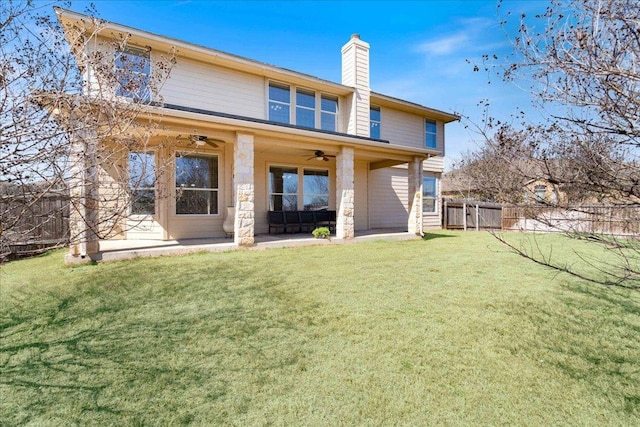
[233,133,255,246]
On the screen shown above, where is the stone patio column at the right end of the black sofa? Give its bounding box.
[336,147,355,239]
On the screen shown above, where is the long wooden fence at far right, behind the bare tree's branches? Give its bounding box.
[502,204,640,236]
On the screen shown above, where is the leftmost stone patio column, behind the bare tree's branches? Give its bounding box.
[65,120,100,264]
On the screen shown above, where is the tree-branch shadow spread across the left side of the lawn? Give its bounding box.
[0,262,316,425]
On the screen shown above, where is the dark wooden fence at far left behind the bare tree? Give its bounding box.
[0,191,69,260]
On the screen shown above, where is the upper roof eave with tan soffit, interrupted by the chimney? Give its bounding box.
[54,7,460,123]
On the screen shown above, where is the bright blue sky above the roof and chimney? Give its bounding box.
[71,0,547,165]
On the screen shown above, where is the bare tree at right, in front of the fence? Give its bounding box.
[464,0,640,288]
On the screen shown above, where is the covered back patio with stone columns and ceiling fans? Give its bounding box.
[66,104,432,264]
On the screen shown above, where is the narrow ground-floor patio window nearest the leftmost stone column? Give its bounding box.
[129,152,156,215]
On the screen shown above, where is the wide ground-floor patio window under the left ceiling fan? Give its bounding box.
[176,155,218,215]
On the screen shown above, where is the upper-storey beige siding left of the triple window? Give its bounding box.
[161,57,266,119]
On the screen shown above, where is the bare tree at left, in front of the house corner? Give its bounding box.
[0,0,175,260]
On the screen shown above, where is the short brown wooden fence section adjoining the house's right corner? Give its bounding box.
[442,200,502,230]
